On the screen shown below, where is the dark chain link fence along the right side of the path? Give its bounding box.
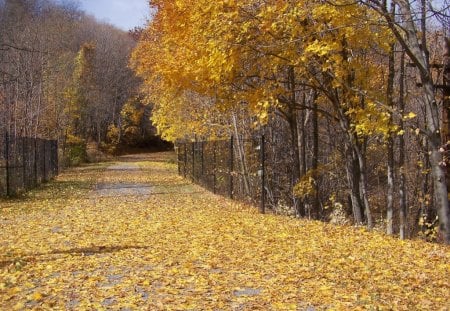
[176,136,296,212]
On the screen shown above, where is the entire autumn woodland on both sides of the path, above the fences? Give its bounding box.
[0,0,450,242]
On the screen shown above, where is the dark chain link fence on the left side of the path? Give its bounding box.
[0,134,58,196]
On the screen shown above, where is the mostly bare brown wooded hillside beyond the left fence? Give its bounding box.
[0,0,151,166]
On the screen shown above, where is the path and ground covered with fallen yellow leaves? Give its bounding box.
[0,153,450,310]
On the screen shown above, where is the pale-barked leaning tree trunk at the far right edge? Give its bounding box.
[363,0,450,244]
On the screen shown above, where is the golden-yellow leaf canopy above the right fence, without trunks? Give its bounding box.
[132,0,391,145]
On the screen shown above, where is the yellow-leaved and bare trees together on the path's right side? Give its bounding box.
[133,0,450,242]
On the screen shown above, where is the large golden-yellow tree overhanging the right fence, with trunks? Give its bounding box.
[133,0,400,227]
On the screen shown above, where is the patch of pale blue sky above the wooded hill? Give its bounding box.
[79,0,150,30]
